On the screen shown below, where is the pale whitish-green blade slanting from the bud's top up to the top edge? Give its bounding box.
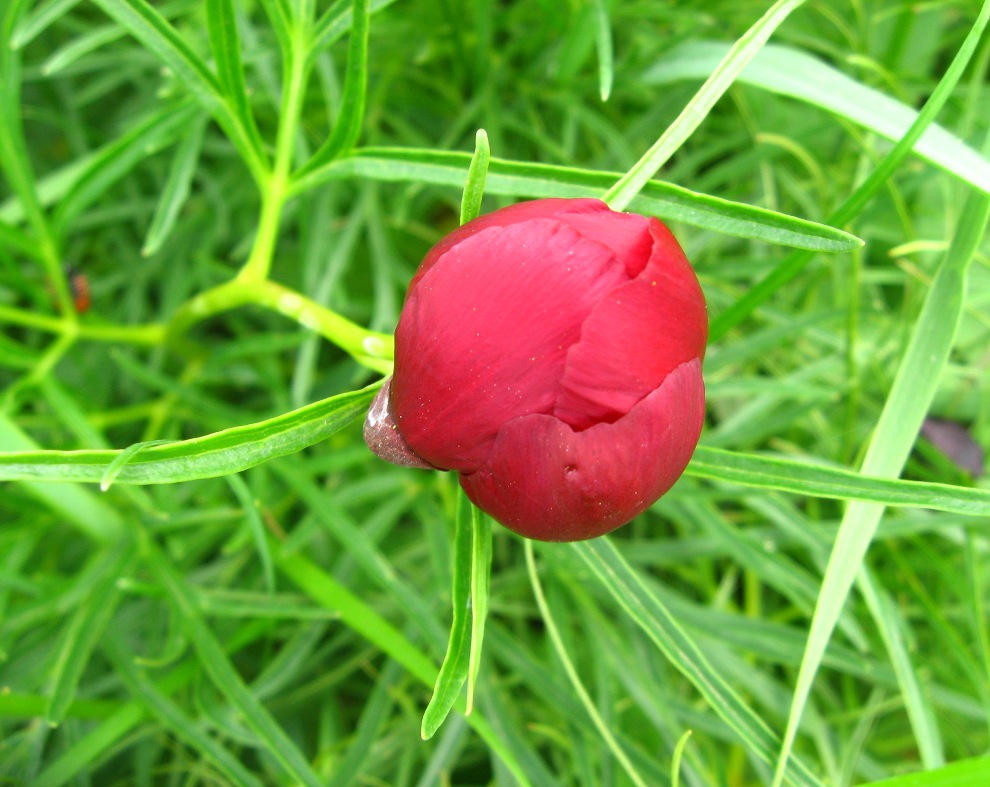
[602,0,804,210]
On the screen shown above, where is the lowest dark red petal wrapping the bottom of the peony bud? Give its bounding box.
[461,359,705,541]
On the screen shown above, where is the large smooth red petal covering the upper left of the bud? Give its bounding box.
[391,218,625,472]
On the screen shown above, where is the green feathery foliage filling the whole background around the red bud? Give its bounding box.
[0,0,990,787]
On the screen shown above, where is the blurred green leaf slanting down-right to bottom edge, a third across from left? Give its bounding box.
[142,539,323,787]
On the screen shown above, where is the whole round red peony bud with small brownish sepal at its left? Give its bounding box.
[365,199,708,541]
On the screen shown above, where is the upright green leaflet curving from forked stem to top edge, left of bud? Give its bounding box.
[299,0,371,175]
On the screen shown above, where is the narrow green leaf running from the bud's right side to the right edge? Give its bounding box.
[686,450,990,516]
